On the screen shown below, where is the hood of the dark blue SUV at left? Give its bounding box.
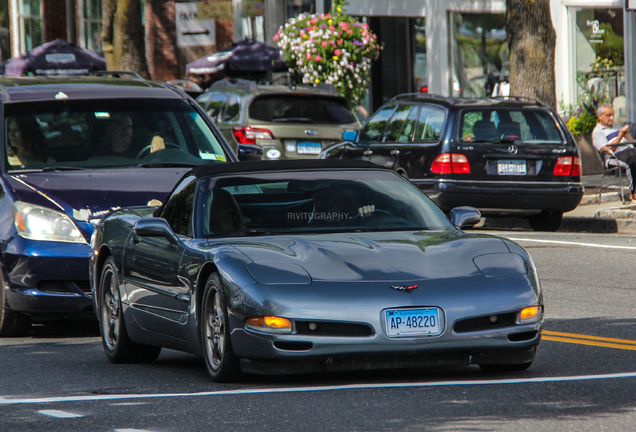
[5,167,189,220]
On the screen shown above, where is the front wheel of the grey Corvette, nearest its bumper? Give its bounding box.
[200,273,241,382]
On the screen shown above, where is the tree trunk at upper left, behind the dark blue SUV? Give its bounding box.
[102,0,150,78]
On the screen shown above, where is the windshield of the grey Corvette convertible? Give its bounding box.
[195,170,454,237]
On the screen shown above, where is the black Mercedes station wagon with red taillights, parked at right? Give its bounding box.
[320,93,583,231]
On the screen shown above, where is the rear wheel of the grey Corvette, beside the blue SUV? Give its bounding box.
[99,257,161,363]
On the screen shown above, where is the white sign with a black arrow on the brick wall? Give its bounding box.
[174,3,216,46]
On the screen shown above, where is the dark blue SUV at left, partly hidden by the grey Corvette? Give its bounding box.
[0,73,237,336]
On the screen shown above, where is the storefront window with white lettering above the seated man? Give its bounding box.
[574,8,625,109]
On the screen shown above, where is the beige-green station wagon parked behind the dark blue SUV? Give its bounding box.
[196,80,361,160]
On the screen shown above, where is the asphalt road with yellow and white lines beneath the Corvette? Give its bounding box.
[0,231,636,432]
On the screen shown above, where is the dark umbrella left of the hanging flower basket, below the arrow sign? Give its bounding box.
[186,39,287,75]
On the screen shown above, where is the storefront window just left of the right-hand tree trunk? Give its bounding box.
[450,13,510,97]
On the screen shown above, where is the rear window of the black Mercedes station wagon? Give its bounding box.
[459,108,564,144]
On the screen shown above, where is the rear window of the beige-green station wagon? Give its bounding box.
[249,94,356,125]
